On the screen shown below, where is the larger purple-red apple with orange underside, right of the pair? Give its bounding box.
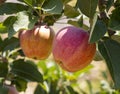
[52,26,96,72]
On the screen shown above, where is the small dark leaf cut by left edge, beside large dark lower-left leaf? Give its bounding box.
[0,62,8,77]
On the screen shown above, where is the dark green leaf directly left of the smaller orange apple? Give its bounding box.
[2,37,19,51]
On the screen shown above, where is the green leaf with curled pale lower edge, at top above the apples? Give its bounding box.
[42,0,63,14]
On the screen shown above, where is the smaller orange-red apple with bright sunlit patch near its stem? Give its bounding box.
[19,25,54,59]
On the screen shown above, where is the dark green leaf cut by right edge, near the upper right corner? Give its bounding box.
[109,7,120,31]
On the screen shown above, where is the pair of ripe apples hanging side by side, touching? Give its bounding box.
[19,25,96,72]
